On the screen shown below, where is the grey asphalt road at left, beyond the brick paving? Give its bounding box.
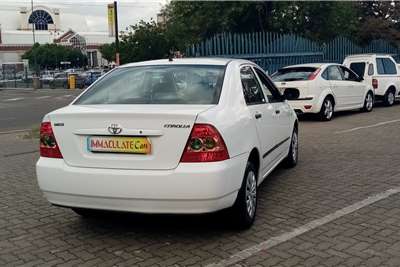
[0,89,82,132]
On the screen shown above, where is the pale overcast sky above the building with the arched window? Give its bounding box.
[0,0,168,31]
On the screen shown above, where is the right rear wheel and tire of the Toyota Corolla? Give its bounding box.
[231,162,257,229]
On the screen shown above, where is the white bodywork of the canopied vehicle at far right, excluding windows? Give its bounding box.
[343,54,400,98]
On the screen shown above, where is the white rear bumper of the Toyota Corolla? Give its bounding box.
[36,154,248,213]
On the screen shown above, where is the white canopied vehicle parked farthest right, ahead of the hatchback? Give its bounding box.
[343,54,400,106]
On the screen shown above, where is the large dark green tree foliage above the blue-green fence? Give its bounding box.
[106,1,400,63]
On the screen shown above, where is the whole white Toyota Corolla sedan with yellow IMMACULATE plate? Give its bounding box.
[36,58,298,227]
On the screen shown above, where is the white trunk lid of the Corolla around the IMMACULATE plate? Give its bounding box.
[48,105,213,170]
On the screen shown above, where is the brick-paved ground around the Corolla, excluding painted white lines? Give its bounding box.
[0,105,400,266]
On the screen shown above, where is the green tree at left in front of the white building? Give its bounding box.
[22,43,87,69]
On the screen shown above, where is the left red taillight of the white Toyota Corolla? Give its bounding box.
[40,122,62,159]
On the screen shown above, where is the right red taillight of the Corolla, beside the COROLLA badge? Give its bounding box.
[181,124,229,162]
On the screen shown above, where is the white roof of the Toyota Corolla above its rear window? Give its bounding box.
[120,57,254,68]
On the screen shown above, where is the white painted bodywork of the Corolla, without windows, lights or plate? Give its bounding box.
[36,59,297,216]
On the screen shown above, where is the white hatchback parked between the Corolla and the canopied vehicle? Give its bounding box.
[271,63,374,121]
